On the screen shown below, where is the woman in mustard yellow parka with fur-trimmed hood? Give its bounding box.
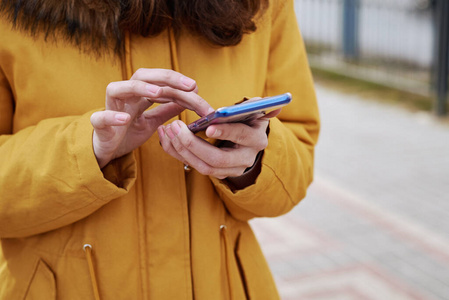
[0,0,319,300]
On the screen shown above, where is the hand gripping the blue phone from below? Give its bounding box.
[157,109,280,179]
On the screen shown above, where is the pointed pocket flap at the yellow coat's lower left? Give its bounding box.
[24,259,56,300]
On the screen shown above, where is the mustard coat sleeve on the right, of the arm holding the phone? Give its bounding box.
[212,0,319,221]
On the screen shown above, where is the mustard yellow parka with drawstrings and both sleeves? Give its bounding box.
[0,0,319,300]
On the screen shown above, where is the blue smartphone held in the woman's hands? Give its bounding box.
[188,93,292,133]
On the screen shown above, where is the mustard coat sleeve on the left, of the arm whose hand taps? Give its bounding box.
[0,68,135,238]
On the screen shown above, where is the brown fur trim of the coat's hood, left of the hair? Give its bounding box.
[0,0,123,53]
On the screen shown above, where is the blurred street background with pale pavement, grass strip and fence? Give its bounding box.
[251,0,449,300]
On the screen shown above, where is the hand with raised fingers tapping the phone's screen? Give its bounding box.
[91,69,213,168]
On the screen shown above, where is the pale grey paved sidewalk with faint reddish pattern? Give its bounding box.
[252,86,449,300]
